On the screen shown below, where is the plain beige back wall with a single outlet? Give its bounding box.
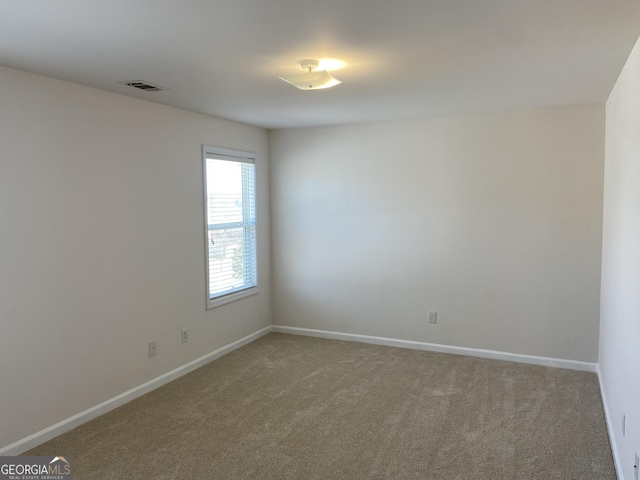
[269,106,604,362]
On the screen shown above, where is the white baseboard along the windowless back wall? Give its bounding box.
[272,325,597,372]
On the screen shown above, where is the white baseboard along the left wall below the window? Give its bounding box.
[0,326,271,456]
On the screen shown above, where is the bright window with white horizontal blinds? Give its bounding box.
[202,145,258,308]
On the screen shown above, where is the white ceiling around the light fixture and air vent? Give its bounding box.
[0,0,640,128]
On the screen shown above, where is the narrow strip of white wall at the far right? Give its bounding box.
[599,35,640,479]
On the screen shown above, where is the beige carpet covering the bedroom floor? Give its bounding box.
[25,334,616,480]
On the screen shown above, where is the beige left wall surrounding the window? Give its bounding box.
[0,68,271,448]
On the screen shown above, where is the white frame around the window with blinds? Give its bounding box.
[202,145,260,310]
